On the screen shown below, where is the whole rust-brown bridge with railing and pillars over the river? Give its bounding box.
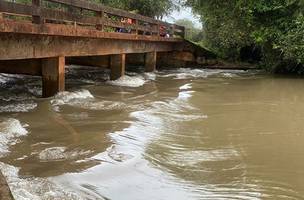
[0,0,215,97]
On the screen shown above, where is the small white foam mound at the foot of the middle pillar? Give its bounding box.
[107,75,146,87]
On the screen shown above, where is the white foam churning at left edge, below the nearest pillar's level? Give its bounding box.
[0,118,28,157]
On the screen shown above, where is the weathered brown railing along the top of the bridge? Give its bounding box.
[0,0,185,38]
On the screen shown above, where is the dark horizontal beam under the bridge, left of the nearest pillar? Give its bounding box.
[0,59,42,76]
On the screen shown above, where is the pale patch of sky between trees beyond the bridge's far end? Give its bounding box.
[164,8,202,28]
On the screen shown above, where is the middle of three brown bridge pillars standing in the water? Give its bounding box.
[110,54,126,80]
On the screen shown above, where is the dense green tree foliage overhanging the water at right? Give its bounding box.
[186,0,304,73]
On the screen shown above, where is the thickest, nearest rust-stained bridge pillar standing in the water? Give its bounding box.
[42,56,65,97]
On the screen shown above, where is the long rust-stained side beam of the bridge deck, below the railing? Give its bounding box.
[0,29,178,60]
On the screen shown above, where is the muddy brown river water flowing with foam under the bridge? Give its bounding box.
[0,66,304,200]
